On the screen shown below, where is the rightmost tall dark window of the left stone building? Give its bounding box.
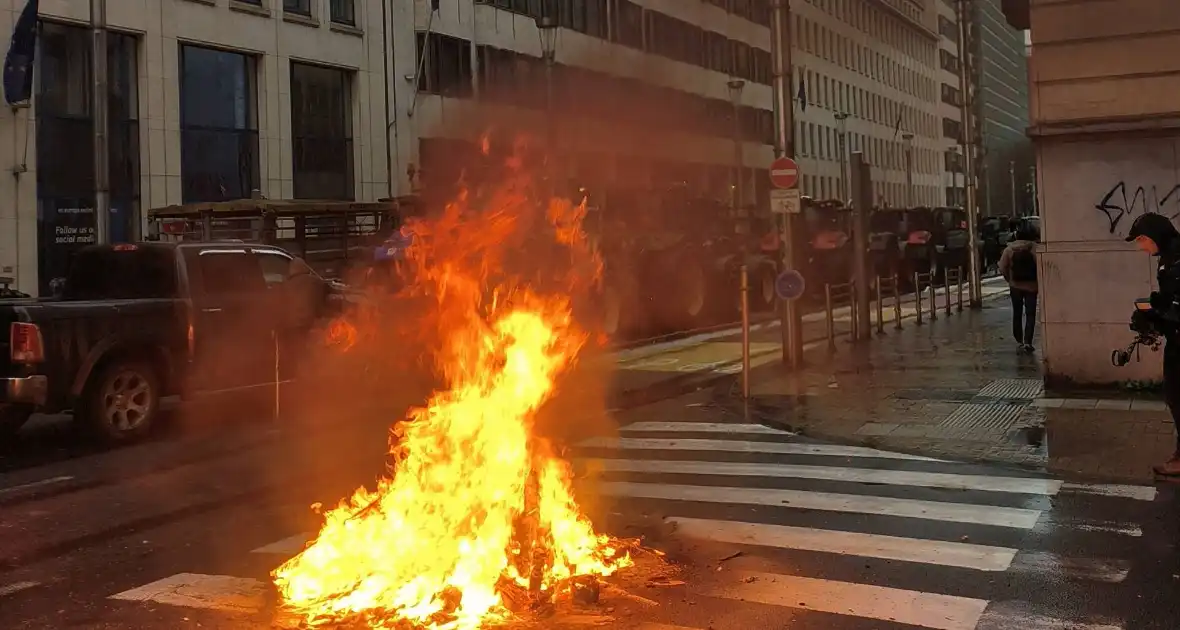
[290,61,354,199]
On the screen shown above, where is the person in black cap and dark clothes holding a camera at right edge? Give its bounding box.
[1127,214,1180,478]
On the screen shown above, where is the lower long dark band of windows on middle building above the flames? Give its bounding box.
[418,33,774,144]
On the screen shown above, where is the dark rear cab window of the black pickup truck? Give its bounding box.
[61,248,177,300]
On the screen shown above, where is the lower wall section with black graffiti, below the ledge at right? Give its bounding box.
[1038,137,1165,383]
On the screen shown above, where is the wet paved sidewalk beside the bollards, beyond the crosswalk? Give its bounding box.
[722,296,1173,481]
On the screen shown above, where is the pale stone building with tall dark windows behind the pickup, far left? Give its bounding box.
[0,0,387,293]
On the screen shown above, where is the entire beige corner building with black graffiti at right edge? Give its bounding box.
[1004,0,1180,386]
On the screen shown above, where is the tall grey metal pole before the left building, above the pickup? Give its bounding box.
[90,0,111,244]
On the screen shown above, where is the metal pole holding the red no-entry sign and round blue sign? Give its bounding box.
[771,0,804,369]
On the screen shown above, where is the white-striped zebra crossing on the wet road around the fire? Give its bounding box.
[112,421,1155,630]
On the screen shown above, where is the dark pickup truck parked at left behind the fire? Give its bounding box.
[0,242,342,442]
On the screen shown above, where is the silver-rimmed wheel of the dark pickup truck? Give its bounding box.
[79,359,160,444]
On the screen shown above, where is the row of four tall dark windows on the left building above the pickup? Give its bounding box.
[34,22,353,202]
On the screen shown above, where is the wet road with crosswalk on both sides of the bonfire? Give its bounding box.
[0,393,1180,630]
